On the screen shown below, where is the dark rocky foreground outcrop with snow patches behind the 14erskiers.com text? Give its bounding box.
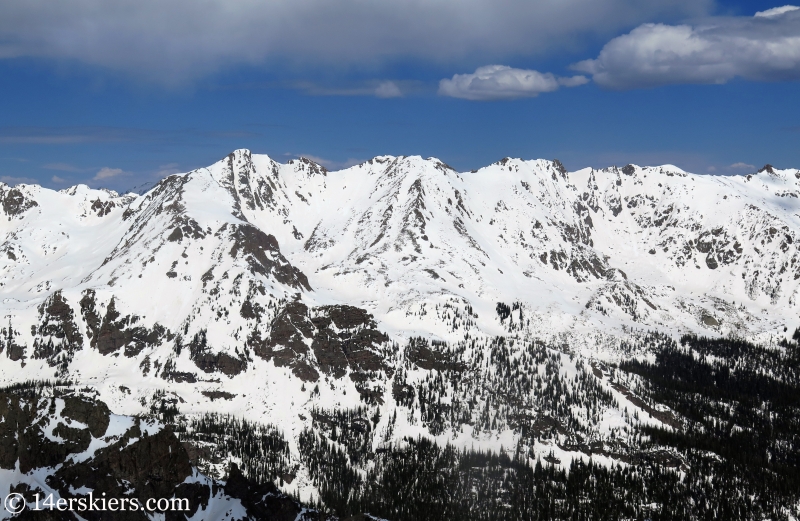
[0,385,327,521]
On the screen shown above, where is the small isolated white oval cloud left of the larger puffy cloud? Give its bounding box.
[439,65,589,101]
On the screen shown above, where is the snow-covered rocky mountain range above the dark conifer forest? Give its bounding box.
[0,150,800,508]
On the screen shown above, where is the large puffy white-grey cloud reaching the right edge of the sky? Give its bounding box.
[572,6,800,89]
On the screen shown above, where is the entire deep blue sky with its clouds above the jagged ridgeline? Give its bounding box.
[0,0,800,190]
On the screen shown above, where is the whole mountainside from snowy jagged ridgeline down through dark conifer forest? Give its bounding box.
[0,150,800,521]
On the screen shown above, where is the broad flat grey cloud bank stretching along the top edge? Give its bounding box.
[0,0,713,83]
